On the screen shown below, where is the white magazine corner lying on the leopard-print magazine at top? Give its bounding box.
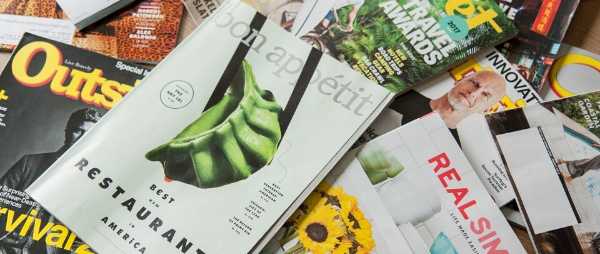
[55,0,136,30]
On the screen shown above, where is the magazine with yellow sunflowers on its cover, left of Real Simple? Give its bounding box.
[261,152,413,254]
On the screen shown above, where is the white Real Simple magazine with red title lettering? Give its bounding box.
[357,114,525,254]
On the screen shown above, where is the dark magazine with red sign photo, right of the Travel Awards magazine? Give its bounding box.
[497,0,579,91]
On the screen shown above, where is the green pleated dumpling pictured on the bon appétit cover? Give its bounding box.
[146,61,282,188]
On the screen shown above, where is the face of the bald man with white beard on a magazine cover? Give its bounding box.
[430,71,506,128]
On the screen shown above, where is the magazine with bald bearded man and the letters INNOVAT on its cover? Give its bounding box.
[356,49,542,206]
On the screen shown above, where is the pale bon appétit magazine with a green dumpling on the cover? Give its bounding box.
[28,1,393,254]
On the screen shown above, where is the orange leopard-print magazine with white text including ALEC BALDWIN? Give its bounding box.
[0,0,183,64]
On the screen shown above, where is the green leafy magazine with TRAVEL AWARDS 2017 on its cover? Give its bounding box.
[244,0,517,93]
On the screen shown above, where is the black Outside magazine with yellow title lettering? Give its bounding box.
[0,34,148,254]
